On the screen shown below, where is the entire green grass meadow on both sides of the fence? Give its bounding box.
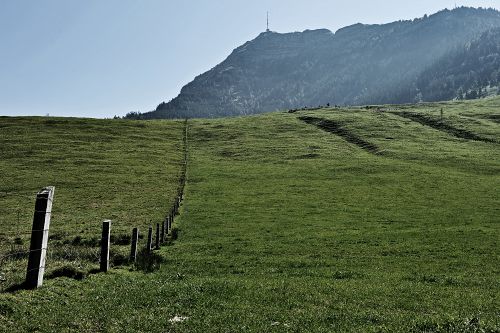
[0,98,500,332]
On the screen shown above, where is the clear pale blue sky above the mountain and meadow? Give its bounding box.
[0,0,500,117]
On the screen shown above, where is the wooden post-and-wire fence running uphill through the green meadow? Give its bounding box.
[0,120,188,291]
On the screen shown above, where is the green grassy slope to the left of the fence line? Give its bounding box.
[0,117,183,289]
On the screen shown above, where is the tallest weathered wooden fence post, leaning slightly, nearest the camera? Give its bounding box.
[26,186,55,289]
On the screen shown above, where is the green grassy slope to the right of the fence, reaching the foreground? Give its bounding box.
[0,99,500,332]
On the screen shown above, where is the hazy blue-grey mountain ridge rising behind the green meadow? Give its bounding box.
[141,7,500,119]
